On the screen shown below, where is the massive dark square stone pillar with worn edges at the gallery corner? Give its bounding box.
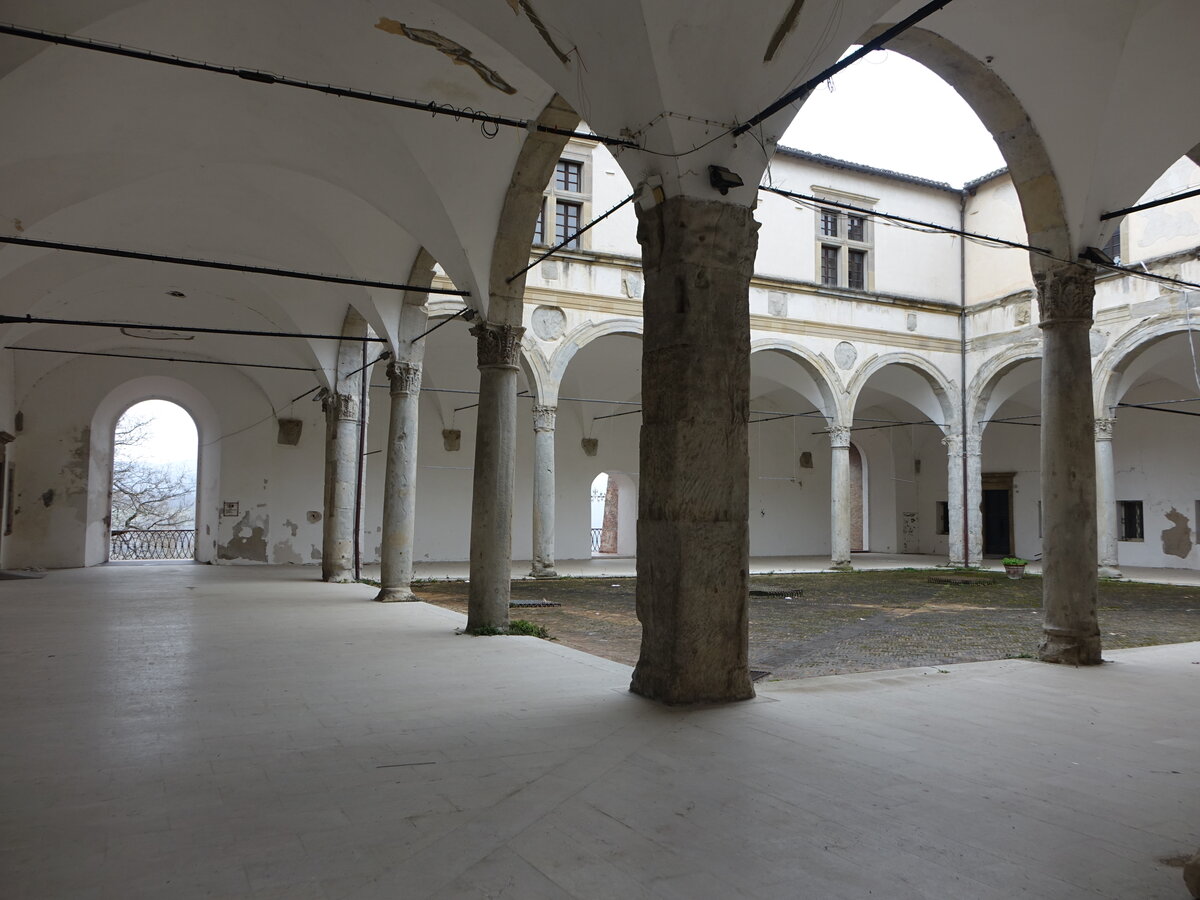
[630,197,758,703]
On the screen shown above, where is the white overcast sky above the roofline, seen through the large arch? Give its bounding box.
[781,50,1004,187]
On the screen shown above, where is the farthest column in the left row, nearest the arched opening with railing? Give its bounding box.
[320,390,359,583]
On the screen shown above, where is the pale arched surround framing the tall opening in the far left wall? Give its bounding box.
[84,376,221,565]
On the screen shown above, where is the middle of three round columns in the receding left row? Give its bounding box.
[376,361,421,602]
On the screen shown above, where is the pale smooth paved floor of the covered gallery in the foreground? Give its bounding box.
[0,565,1200,900]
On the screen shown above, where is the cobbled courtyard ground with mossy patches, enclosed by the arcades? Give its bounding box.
[414,570,1200,679]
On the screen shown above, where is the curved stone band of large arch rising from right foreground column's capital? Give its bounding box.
[862,24,1075,262]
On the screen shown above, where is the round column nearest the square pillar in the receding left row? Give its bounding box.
[467,322,524,631]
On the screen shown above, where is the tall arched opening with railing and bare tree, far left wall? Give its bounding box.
[109,400,197,560]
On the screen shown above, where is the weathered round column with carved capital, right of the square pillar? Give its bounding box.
[1033,265,1102,666]
